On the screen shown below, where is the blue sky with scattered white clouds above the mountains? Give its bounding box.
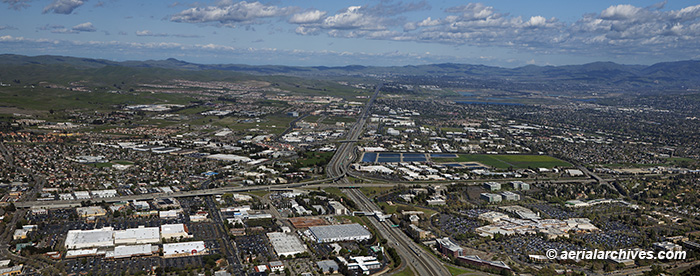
[0,0,700,67]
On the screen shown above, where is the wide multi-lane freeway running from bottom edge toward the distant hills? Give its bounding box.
[326,85,451,276]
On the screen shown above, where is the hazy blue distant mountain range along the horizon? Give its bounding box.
[0,54,700,90]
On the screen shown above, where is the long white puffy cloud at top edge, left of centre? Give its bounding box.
[170,1,296,24]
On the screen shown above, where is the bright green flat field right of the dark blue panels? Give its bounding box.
[433,154,571,169]
